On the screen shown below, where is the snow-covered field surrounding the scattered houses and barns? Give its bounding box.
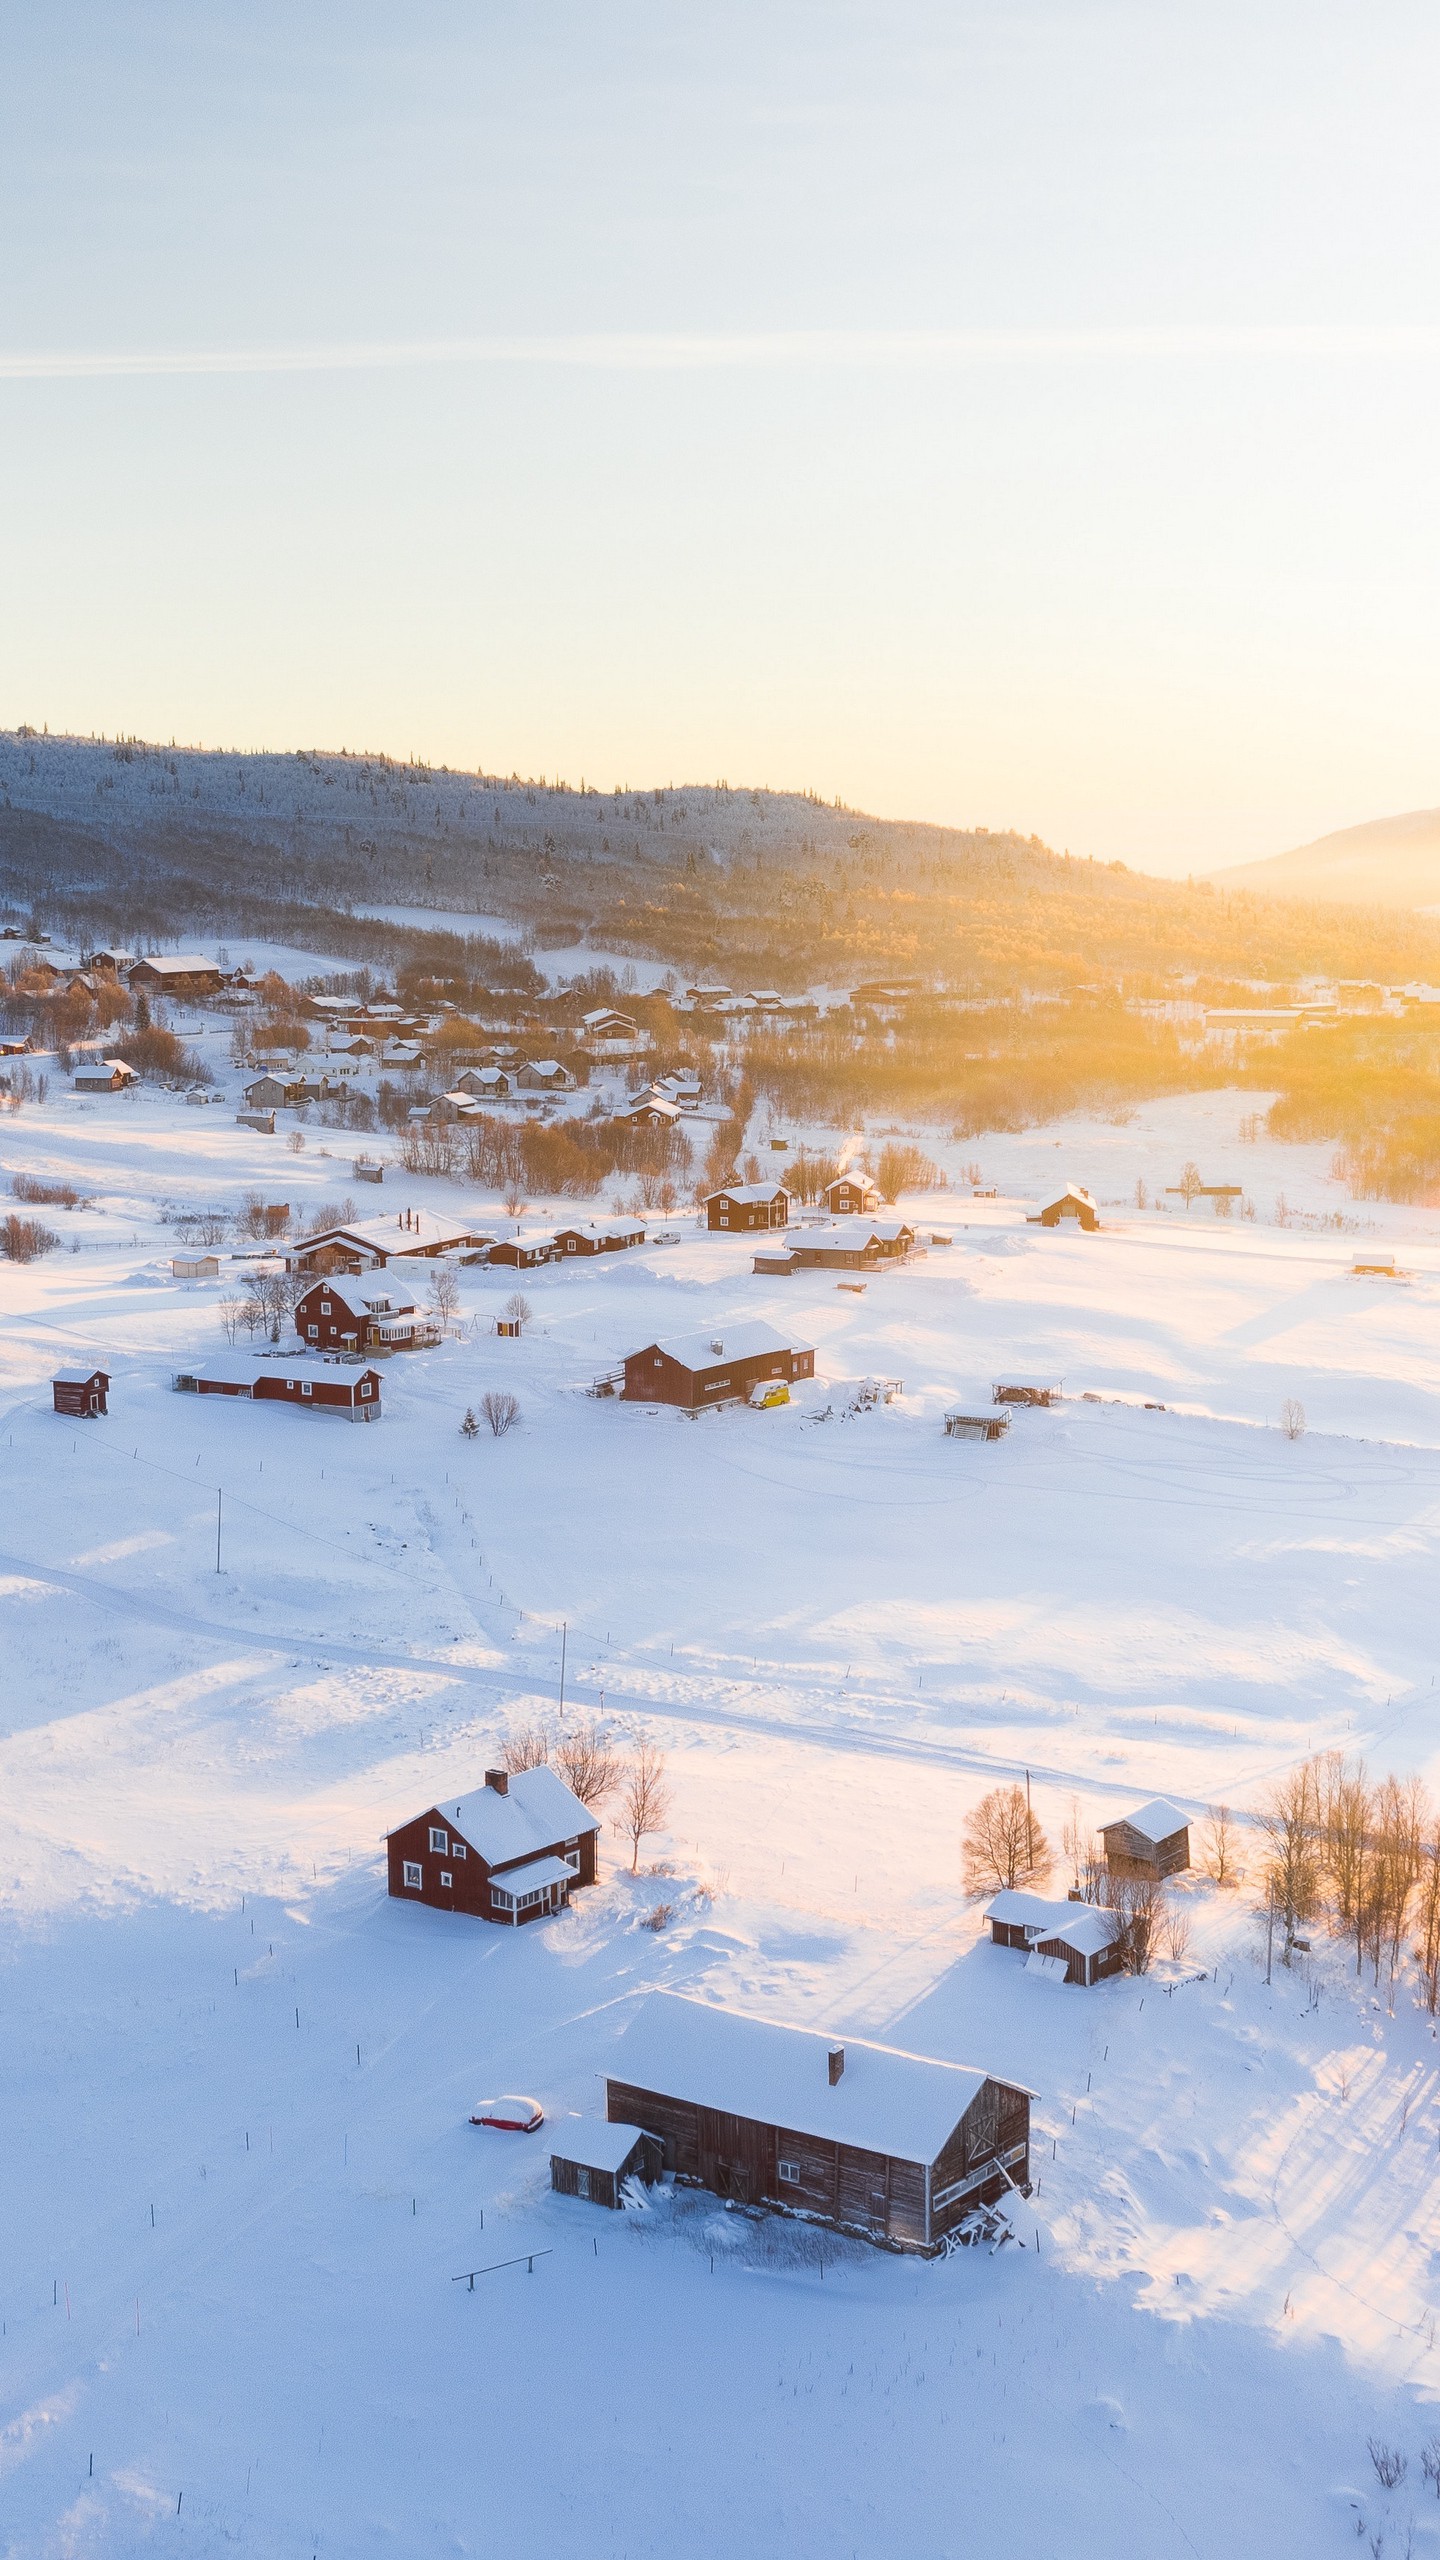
[0,1093,1440,2560]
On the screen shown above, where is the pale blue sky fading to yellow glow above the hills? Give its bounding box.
[0,0,1440,870]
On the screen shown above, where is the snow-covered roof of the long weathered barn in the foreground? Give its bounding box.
[610,1992,1014,2161]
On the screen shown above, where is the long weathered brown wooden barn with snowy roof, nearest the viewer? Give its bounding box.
[605,1992,1033,2250]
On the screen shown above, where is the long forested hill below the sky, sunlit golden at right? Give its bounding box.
[0,730,1440,993]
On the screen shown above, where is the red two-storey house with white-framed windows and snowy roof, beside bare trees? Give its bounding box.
[384,1766,600,1928]
